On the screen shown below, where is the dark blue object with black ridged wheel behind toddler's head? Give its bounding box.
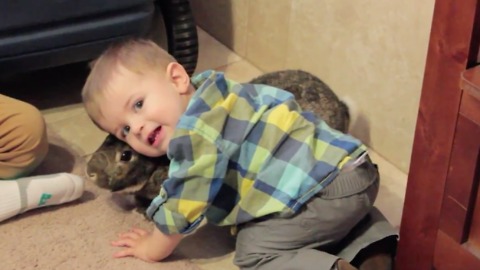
[0,0,198,75]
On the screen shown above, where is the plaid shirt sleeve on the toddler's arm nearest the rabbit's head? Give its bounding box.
[147,127,228,234]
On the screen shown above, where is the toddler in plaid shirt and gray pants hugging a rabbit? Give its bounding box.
[82,40,390,269]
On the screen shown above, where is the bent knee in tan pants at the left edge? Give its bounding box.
[0,95,48,179]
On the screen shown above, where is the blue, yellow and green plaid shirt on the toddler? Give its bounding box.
[147,71,366,234]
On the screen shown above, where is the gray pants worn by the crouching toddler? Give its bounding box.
[234,159,386,270]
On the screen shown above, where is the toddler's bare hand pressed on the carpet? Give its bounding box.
[112,226,183,262]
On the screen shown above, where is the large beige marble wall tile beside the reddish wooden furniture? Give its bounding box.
[286,0,434,171]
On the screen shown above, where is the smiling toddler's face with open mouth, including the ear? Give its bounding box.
[96,63,193,157]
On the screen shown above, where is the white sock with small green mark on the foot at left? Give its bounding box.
[0,173,84,222]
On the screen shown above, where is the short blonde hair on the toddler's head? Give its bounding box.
[82,39,176,120]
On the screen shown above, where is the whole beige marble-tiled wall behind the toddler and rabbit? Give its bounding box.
[192,0,434,172]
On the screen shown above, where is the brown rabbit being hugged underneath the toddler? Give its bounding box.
[87,70,350,211]
